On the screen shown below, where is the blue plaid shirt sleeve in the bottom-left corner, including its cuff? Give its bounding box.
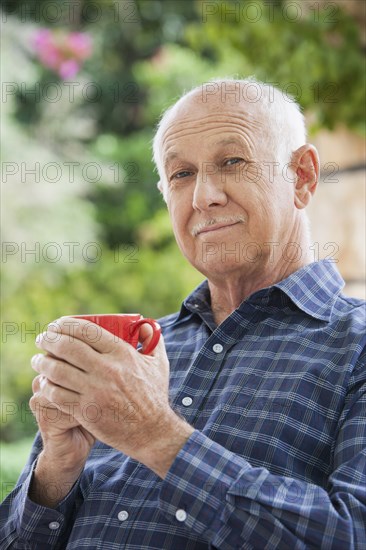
[0,433,80,550]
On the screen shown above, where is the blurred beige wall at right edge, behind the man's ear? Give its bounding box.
[308,128,366,298]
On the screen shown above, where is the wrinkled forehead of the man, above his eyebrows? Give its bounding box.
[161,97,268,161]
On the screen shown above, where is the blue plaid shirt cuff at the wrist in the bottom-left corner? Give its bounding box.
[13,461,79,550]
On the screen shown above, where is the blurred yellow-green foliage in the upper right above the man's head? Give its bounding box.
[186,0,365,133]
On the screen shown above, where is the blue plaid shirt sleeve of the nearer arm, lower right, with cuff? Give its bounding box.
[159,356,366,550]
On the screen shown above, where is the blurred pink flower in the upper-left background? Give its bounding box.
[33,29,92,79]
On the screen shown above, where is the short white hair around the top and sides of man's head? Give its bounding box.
[153,77,306,200]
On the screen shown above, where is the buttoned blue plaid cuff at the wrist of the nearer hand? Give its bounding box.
[159,430,251,540]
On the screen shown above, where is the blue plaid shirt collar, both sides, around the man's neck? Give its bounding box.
[177,260,344,321]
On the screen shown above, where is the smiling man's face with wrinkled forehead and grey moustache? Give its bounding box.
[162,94,295,279]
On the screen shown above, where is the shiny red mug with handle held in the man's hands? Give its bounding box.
[71,313,161,355]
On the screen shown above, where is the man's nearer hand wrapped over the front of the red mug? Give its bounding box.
[32,317,194,477]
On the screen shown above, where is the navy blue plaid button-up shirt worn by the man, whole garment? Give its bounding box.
[0,261,366,550]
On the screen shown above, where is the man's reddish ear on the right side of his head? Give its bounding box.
[290,143,319,209]
